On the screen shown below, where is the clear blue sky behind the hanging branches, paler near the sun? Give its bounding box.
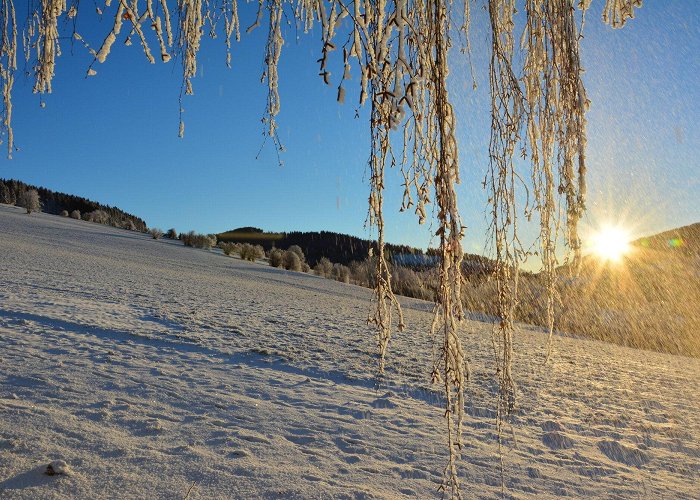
[0,0,700,262]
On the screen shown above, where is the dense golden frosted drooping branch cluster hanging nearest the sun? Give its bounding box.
[522,0,588,364]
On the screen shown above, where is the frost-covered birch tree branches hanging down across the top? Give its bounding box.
[0,0,641,496]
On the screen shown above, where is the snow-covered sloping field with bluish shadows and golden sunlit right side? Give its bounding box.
[0,205,700,498]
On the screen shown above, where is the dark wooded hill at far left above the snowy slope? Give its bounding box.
[0,179,147,232]
